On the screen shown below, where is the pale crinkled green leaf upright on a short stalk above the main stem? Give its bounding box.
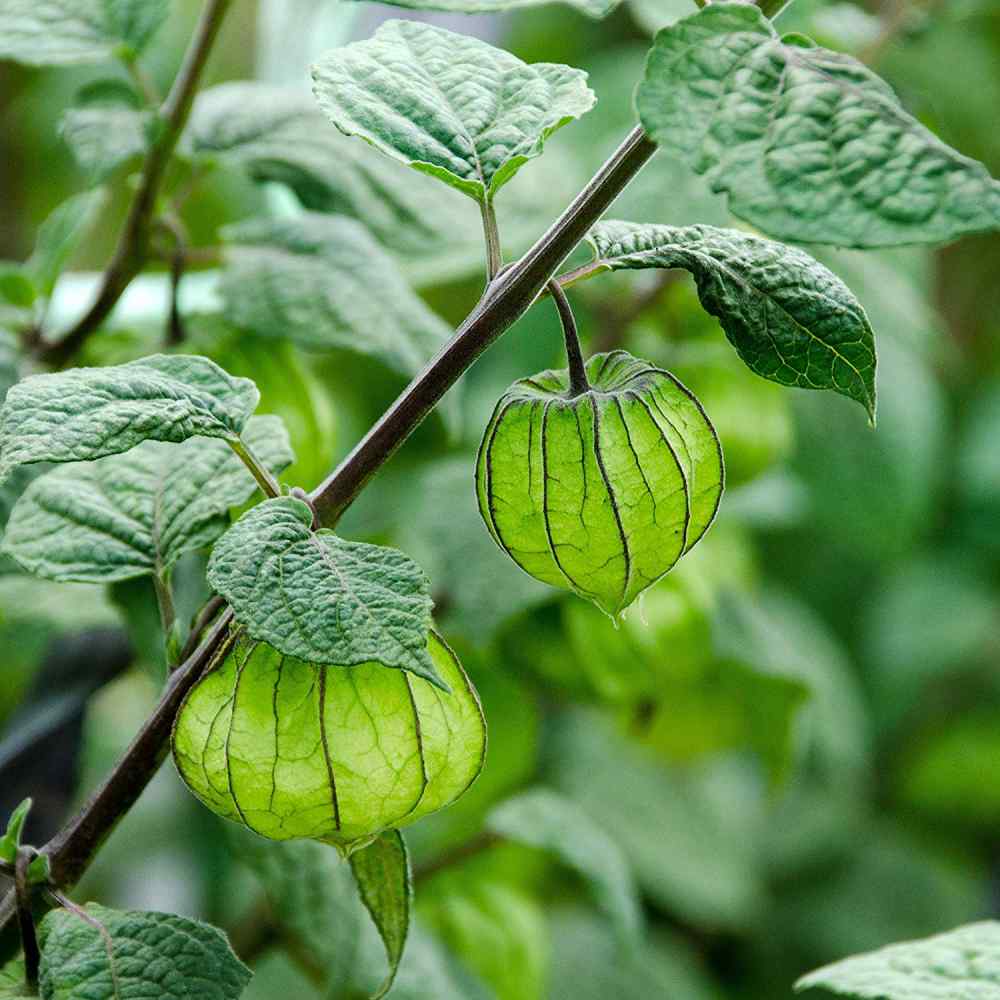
[313,21,594,201]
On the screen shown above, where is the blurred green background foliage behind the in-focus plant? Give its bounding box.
[0,0,1000,1000]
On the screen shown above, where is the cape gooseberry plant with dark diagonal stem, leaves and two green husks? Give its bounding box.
[0,0,1000,1000]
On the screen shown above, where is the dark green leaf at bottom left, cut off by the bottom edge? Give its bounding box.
[39,903,252,1000]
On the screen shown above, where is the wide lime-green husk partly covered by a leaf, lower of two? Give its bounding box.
[173,633,486,848]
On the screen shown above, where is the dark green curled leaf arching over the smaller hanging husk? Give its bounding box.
[588,222,875,421]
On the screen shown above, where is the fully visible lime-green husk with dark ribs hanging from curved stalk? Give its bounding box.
[476,351,723,615]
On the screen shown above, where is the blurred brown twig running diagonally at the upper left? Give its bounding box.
[39,0,232,367]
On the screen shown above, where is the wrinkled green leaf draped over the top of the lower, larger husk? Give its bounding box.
[208,497,447,689]
